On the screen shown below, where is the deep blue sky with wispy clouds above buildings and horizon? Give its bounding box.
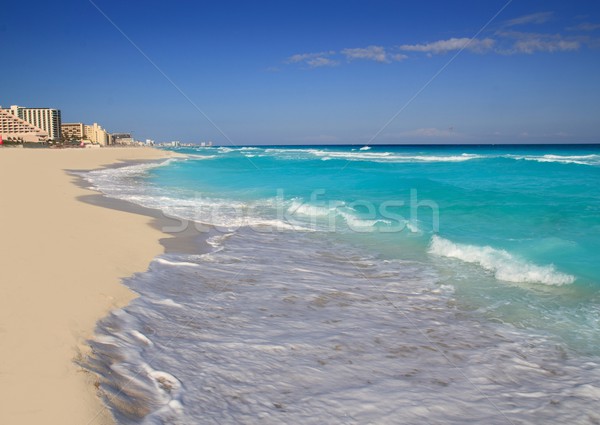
[0,0,600,145]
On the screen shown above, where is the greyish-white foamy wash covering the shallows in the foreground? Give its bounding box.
[88,229,599,425]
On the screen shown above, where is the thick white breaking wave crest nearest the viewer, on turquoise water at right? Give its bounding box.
[429,235,575,286]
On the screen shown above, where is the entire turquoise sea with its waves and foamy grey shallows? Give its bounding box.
[83,146,600,424]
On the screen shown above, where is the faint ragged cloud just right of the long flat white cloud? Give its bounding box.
[499,31,581,54]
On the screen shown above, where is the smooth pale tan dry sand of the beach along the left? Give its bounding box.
[0,148,177,425]
